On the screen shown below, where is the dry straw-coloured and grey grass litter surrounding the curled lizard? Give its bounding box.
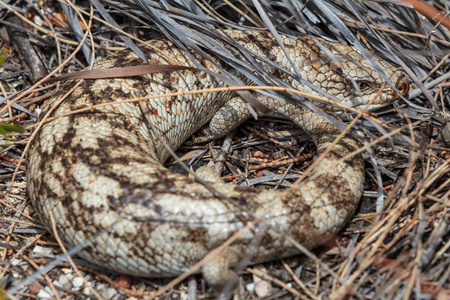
[0,0,450,299]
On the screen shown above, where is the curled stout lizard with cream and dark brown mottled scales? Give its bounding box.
[27,31,407,285]
